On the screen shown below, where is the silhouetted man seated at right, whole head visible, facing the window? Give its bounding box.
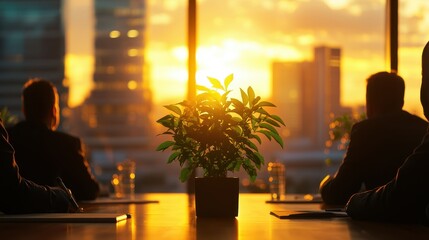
[320,72,428,205]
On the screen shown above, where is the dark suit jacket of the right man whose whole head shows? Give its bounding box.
[320,111,428,204]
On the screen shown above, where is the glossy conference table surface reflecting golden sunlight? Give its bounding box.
[0,193,429,240]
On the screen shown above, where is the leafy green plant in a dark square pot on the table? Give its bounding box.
[156,74,284,217]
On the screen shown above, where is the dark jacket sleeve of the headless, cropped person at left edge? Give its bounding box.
[0,119,70,213]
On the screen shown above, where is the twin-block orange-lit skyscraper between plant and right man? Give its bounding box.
[273,46,344,150]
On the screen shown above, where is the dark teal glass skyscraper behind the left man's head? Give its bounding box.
[0,0,68,122]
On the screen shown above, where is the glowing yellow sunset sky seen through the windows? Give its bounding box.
[65,0,429,118]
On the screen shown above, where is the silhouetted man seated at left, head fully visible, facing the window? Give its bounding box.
[8,79,100,201]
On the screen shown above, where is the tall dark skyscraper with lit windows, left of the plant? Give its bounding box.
[77,0,151,167]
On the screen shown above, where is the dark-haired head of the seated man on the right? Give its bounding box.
[366,72,405,118]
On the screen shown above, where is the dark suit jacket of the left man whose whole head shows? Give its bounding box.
[8,121,99,201]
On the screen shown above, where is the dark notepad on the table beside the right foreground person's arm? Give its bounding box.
[270,210,348,219]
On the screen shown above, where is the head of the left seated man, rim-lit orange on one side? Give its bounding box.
[22,78,60,130]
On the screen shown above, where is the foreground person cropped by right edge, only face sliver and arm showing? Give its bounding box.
[346,42,429,222]
